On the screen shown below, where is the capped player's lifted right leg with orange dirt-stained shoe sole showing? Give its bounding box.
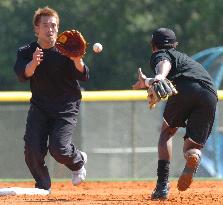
[177,87,217,191]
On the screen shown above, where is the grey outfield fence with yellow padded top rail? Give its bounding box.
[0,90,223,179]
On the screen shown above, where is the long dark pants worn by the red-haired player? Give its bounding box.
[24,101,84,189]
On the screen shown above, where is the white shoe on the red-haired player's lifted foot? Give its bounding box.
[72,152,87,186]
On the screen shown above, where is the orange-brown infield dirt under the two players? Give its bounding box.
[0,180,223,205]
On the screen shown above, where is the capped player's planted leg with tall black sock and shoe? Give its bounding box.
[151,83,193,199]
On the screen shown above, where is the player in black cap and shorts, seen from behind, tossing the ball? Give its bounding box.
[132,28,218,200]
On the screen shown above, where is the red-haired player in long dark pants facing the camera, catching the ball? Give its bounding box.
[14,7,89,190]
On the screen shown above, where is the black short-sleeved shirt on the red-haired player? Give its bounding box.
[14,42,89,112]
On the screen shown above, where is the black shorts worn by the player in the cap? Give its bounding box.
[164,80,218,146]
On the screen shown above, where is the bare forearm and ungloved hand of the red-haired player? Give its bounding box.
[25,47,43,77]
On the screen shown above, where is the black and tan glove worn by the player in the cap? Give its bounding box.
[147,79,177,109]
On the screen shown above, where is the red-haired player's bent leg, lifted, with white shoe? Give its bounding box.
[49,101,87,185]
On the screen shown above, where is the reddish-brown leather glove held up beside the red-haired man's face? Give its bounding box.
[55,30,87,57]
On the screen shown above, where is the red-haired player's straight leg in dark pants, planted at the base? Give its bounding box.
[24,104,51,190]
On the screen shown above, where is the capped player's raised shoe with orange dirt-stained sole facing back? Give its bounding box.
[177,153,200,191]
